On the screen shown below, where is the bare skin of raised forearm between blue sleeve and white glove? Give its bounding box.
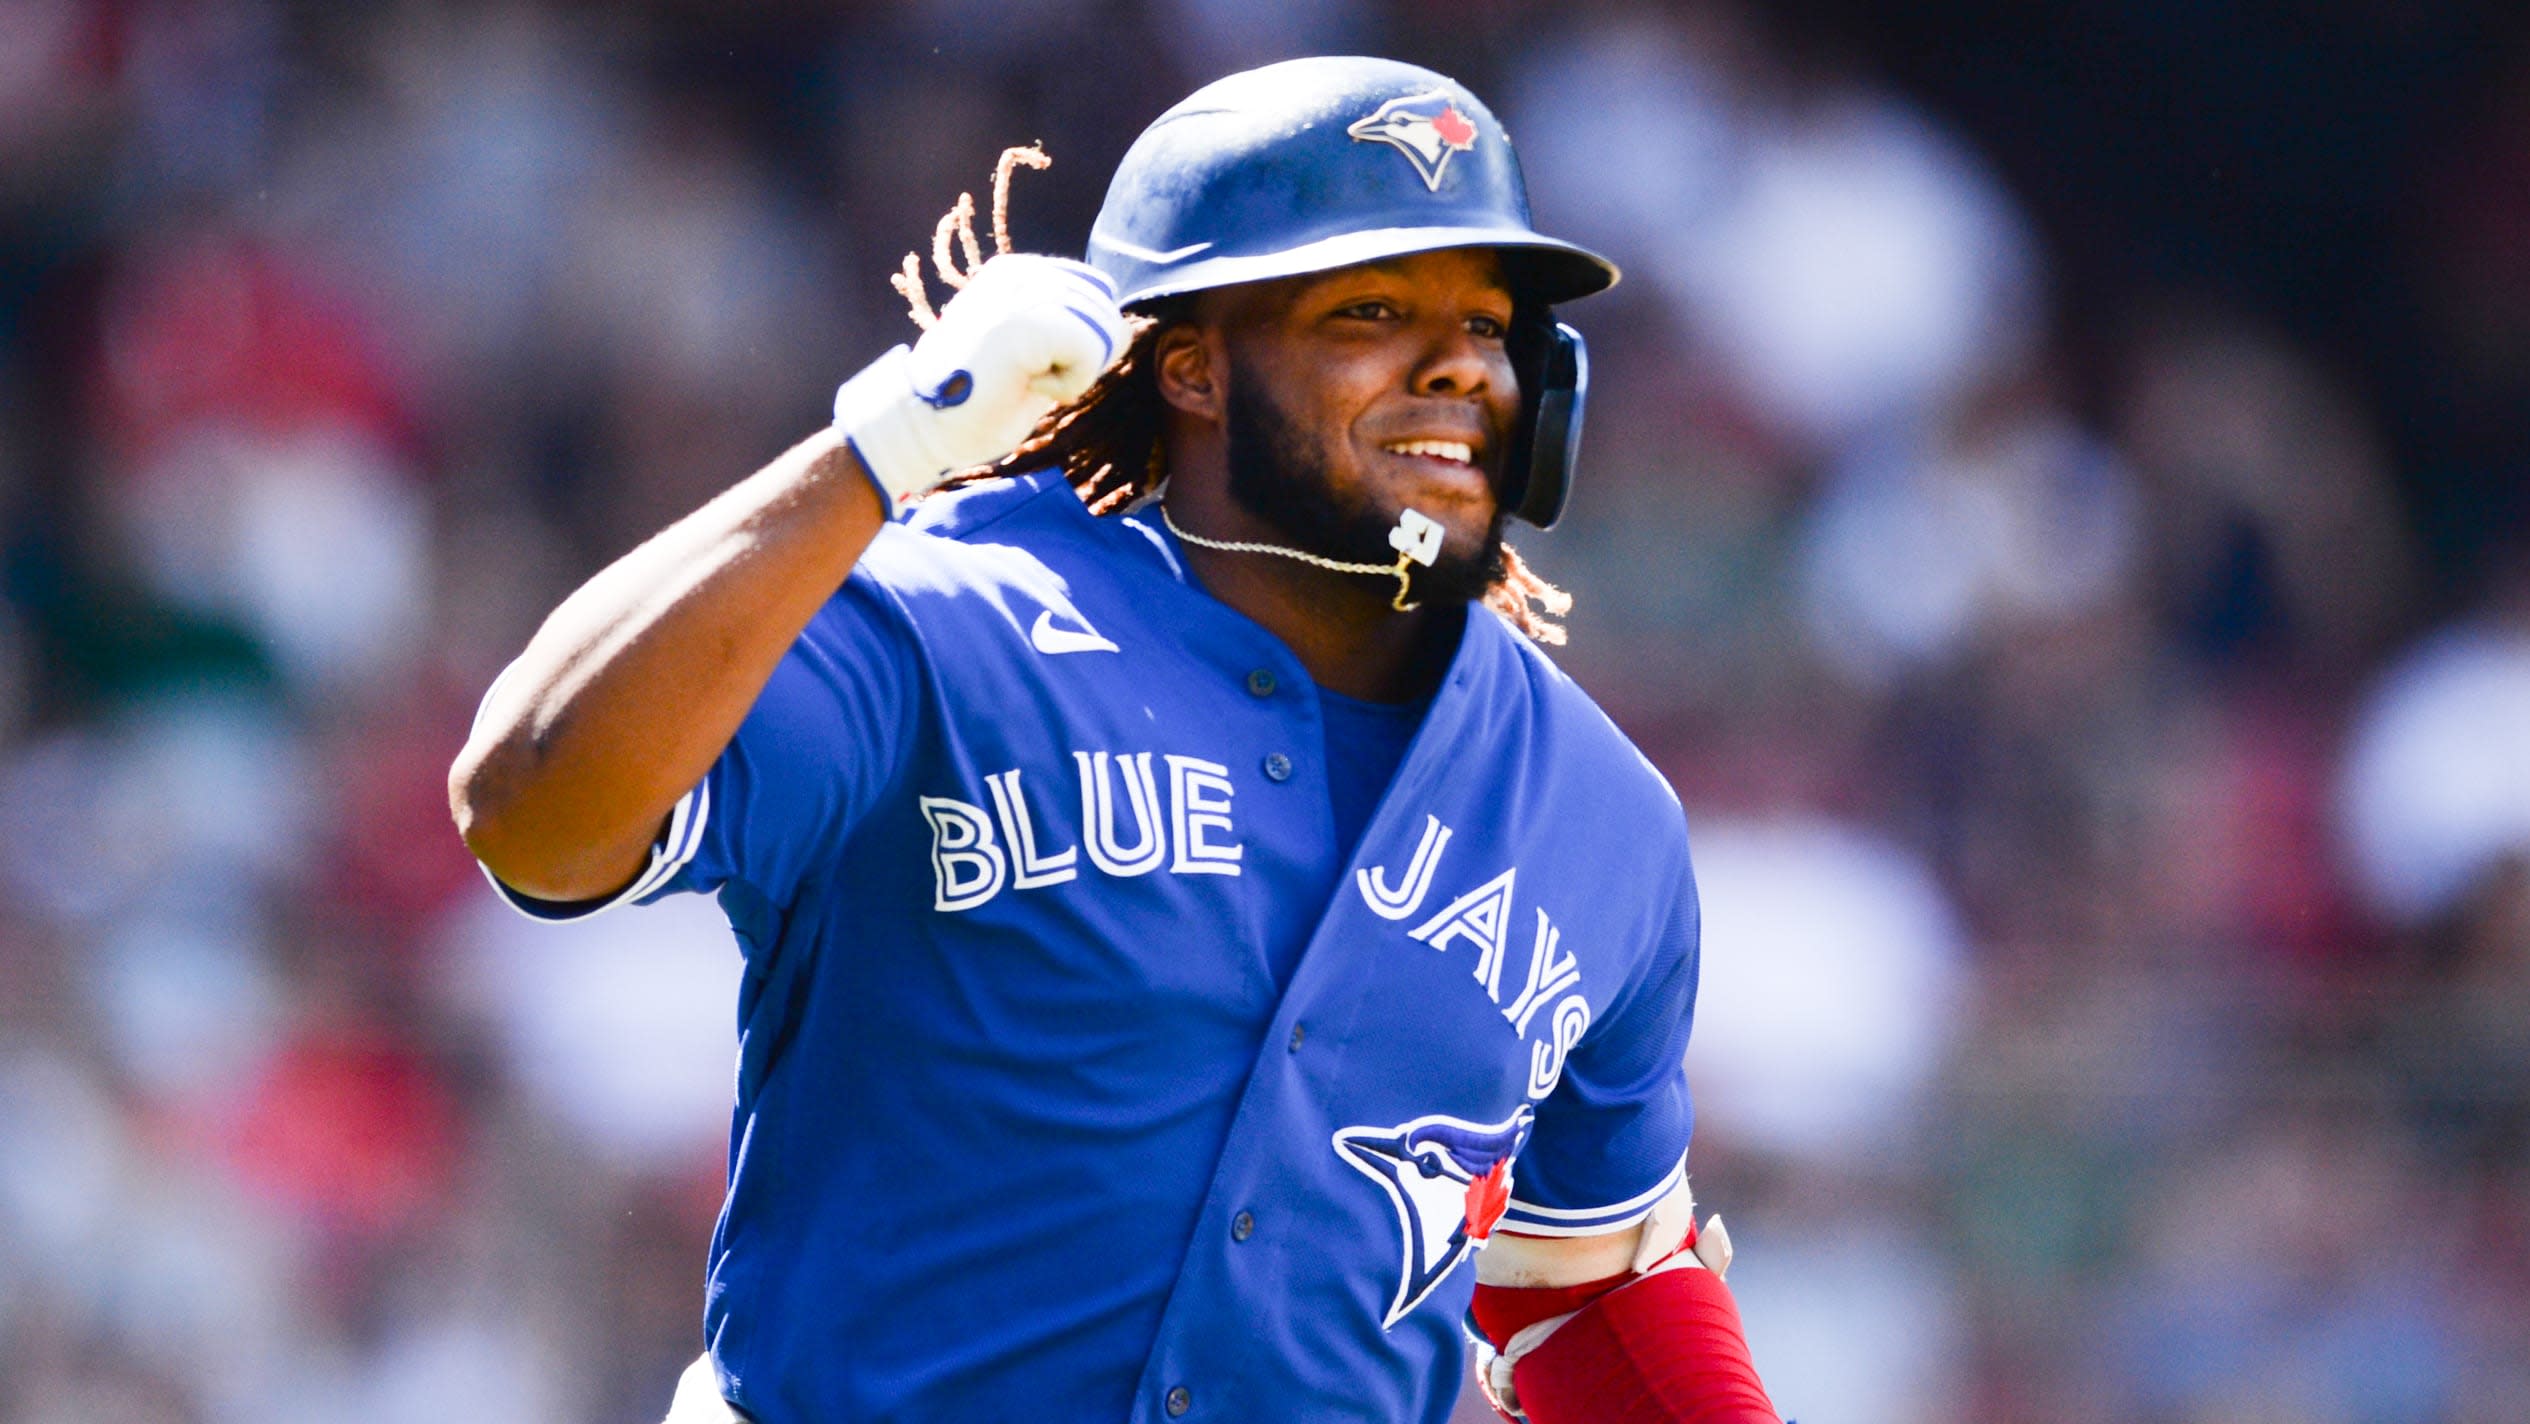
[448,433,886,900]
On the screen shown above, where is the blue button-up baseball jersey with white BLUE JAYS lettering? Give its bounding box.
[480,476,1698,1424]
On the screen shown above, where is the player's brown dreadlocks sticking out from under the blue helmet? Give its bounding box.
[888,144,1574,645]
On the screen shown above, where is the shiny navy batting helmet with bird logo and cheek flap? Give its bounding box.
[1088,58,1617,529]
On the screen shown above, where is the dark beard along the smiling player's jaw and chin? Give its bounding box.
[1225,379,1508,605]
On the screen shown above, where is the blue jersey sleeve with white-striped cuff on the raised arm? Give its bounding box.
[486,572,918,921]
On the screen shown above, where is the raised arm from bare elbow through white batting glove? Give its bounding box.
[448,253,1126,900]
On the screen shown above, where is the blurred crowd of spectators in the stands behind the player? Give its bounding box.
[0,0,2530,1424]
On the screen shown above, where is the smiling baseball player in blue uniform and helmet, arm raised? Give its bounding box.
[450,58,1776,1424]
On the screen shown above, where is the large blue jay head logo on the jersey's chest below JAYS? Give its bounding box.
[1336,1103,1536,1330]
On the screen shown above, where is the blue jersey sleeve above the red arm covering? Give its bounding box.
[1503,842,1700,1237]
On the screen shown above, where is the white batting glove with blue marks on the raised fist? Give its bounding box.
[835,253,1126,511]
